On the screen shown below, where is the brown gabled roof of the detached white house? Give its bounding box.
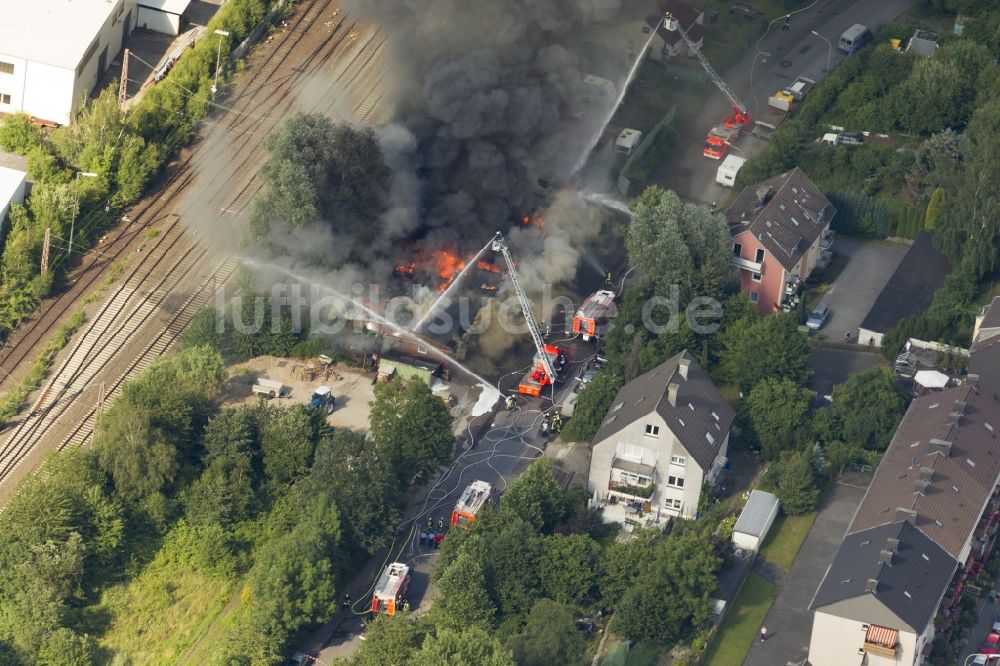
[593,349,735,469]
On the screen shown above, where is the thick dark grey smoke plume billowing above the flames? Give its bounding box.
[345,0,640,254]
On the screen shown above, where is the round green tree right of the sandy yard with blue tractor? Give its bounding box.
[369,378,455,484]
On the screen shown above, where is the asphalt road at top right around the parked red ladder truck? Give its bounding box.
[656,0,912,203]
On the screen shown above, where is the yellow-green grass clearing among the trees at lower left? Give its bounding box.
[95,556,236,664]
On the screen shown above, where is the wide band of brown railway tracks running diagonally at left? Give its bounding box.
[0,0,394,486]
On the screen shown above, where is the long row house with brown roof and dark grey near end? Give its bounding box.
[809,378,1000,666]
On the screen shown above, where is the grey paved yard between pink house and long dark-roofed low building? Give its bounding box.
[817,237,908,342]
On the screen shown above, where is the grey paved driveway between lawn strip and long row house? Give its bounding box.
[743,475,870,666]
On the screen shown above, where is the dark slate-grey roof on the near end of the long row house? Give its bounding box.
[809,520,958,633]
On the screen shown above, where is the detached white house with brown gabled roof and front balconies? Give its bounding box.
[587,350,735,525]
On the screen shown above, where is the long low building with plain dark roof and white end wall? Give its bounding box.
[858,232,951,347]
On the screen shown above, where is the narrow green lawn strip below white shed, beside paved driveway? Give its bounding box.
[701,571,778,666]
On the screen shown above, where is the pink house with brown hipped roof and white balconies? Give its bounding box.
[726,167,837,314]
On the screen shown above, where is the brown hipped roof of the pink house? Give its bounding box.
[726,167,837,272]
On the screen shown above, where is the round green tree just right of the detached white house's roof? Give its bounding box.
[746,377,810,460]
